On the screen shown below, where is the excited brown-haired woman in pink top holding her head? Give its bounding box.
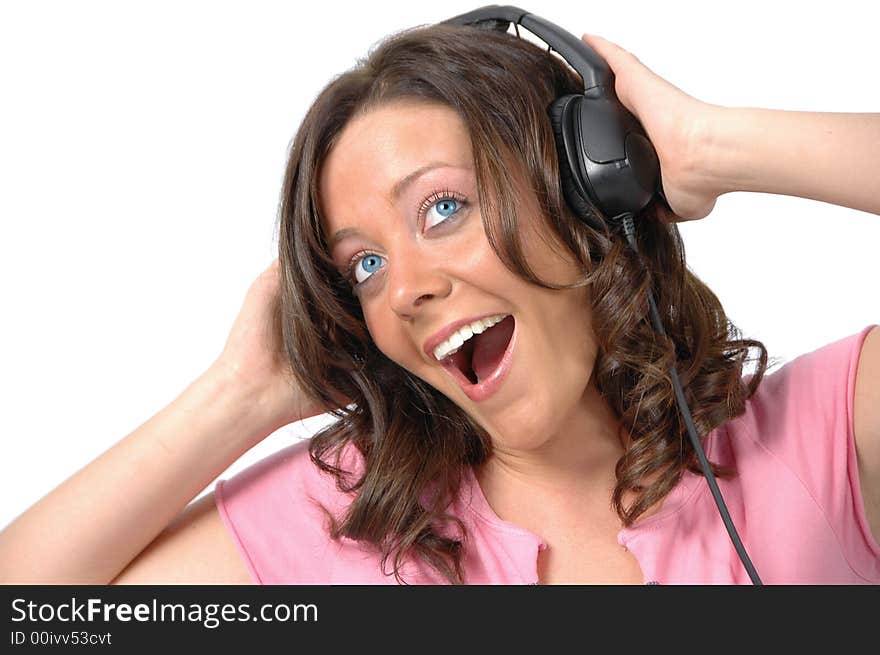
[0,19,880,583]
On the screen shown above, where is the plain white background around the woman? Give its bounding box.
[0,0,880,526]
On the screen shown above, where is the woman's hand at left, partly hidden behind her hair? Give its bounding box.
[212,259,340,429]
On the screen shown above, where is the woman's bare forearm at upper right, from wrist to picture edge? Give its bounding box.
[698,106,880,214]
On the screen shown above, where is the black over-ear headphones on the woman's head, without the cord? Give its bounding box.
[443,5,663,230]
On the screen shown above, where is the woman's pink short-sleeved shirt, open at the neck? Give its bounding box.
[215,326,880,584]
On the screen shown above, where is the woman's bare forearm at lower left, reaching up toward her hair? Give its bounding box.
[0,370,272,584]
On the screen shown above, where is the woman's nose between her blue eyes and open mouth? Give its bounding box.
[387,248,452,319]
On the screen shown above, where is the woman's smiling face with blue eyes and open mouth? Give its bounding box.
[320,101,596,449]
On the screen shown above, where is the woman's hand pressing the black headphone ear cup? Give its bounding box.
[582,34,723,221]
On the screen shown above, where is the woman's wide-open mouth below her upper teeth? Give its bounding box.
[441,315,516,400]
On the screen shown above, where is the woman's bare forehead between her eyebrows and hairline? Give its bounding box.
[318,101,473,231]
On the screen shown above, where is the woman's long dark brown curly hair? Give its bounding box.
[279,24,767,584]
